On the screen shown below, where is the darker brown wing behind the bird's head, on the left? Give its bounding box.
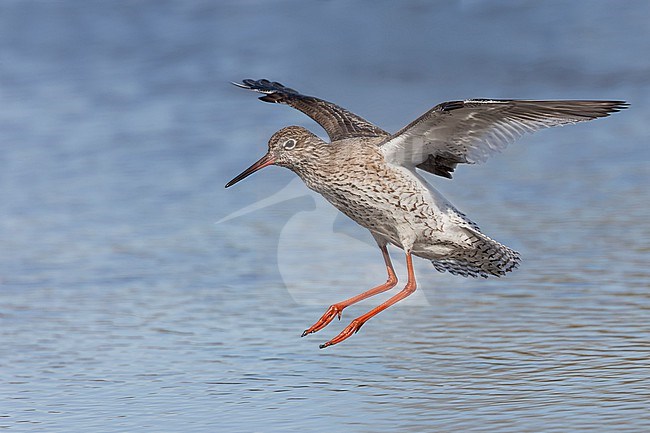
[232,80,390,141]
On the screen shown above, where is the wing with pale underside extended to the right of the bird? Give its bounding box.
[380,99,628,178]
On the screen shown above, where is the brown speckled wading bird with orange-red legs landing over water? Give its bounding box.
[226,79,629,349]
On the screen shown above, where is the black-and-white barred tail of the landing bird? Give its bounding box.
[431,228,520,278]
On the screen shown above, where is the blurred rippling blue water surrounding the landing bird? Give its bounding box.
[0,0,650,432]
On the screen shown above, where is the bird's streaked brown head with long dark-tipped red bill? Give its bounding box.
[226,126,326,188]
